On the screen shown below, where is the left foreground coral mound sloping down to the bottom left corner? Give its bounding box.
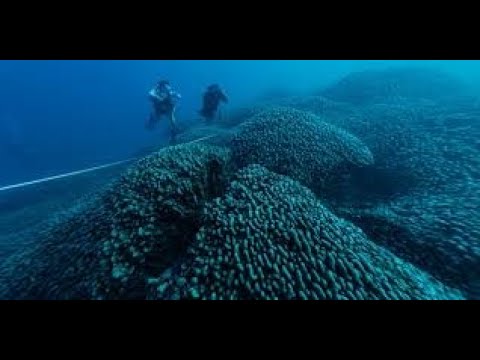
[0,144,229,299]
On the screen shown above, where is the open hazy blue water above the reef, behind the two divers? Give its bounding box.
[0,60,480,185]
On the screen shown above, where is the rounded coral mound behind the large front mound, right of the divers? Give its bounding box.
[231,107,374,194]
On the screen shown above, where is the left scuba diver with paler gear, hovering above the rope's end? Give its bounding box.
[146,80,182,143]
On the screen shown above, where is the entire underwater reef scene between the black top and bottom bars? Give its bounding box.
[0,60,480,300]
